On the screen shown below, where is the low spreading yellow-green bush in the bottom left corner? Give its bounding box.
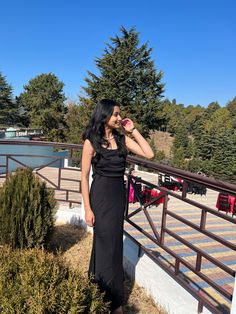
[0,247,109,314]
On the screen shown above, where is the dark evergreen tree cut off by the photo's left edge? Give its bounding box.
[0,72,19,126]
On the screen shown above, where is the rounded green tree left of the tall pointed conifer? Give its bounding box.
[18,73,66,141]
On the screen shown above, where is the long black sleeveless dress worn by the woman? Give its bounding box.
[89,138,126,311]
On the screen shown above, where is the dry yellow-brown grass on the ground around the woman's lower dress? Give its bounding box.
[51,225,166,314]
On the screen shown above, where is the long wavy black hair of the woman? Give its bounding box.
[83,99,127,155]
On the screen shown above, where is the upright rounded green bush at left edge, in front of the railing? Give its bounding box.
[0,168,56,248]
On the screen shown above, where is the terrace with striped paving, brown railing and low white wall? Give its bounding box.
[0,140,236,314]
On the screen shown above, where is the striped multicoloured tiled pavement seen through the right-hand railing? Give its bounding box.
[125,173,236,313]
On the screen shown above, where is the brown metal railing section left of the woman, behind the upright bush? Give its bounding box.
[0,140,82,207]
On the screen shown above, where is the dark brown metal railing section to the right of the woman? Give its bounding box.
[125,156,236,314]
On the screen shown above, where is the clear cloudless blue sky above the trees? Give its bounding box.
[0,0,236,106]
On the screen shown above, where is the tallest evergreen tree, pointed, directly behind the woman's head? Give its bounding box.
[83,27,164,134]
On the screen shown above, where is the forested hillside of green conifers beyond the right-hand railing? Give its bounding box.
[151,98,236,183]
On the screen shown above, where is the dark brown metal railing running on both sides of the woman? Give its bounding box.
[0,140,236,313]
